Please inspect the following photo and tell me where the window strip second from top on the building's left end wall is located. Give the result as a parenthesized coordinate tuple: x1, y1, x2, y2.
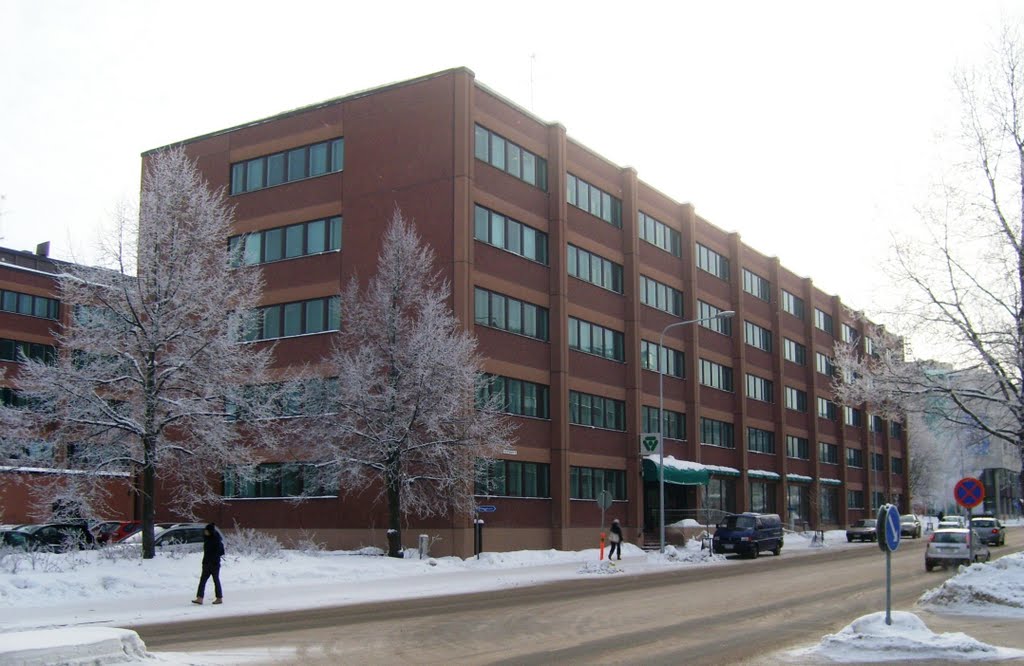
(227, 217, 342, 266)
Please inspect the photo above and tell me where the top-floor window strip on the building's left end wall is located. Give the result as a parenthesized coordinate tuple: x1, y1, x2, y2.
(231, 137, 345, 195)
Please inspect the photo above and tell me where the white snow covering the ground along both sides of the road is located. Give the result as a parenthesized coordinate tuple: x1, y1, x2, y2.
(0, 518, 1024, 664)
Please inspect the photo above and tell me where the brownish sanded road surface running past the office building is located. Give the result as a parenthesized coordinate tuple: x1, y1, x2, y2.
(133, 540, 1024, 664)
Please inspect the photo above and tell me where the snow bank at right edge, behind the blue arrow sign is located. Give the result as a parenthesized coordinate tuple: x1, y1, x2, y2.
(919, 552, 1024, 617)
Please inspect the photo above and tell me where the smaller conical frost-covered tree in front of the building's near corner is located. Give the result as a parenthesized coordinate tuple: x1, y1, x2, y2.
(306, 210, 513, 556)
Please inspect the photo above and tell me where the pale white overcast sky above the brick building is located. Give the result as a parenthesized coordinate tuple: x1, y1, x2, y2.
(0, 0, 1024, 331)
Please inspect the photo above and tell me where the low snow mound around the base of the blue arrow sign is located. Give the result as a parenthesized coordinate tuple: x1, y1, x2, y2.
(786, 611, 1024, 662)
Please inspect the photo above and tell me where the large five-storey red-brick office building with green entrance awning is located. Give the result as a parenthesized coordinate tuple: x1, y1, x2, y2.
(149, 69, 908, 554)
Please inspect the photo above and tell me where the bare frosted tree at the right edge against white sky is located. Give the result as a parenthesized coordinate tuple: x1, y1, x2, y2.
(836, 28, 1024, 491)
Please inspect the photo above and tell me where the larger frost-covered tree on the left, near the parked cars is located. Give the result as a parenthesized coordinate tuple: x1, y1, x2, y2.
(0, 149, 273, 558)
